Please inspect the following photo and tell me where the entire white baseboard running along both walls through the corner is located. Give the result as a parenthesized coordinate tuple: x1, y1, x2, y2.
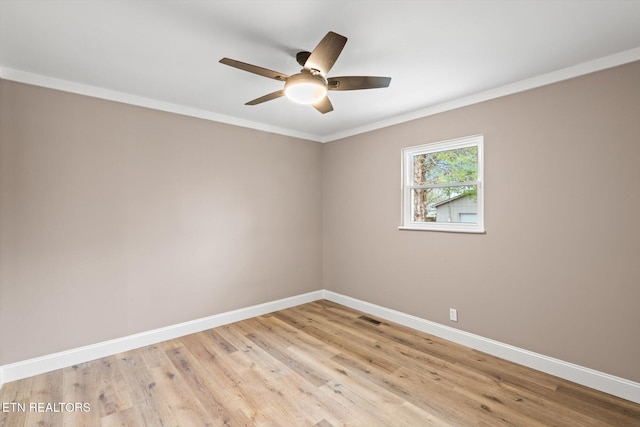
(0, 290, 640, 403)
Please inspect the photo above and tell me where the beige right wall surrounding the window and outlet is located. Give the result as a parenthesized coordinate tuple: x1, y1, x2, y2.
(323, 59, 640, 381)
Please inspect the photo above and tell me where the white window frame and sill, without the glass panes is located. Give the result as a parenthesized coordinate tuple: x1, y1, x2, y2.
(398, 135, 485, 233)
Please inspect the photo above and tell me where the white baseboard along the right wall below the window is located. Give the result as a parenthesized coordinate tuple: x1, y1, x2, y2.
(323, 290, 640, 403)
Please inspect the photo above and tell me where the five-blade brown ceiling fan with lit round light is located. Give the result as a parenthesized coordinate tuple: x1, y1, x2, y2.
(220, 31, 391, 114)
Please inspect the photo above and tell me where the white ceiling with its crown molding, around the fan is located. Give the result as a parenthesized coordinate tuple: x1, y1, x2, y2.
(0, 0, 640, 142)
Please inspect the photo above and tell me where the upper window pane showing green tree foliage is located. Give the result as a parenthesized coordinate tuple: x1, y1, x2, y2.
(413, 147, 478, 185)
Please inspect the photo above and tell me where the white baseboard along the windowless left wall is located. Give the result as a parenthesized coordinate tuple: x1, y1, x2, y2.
(0, 291, 322, 386)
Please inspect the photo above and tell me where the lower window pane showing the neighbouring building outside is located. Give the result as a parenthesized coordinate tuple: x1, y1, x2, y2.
(411, 185, 478, 224)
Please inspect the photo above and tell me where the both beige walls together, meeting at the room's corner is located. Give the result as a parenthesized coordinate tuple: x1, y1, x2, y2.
(0, 63, 640, 381)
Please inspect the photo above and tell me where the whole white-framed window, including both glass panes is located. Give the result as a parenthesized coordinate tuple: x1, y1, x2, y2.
(400, 135, 484, 233)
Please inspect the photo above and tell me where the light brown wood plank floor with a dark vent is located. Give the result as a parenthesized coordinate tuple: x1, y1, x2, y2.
(0, 301, 640, 427)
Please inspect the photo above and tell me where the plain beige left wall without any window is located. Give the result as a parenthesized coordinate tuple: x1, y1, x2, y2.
(0, 81, 322, 365)
